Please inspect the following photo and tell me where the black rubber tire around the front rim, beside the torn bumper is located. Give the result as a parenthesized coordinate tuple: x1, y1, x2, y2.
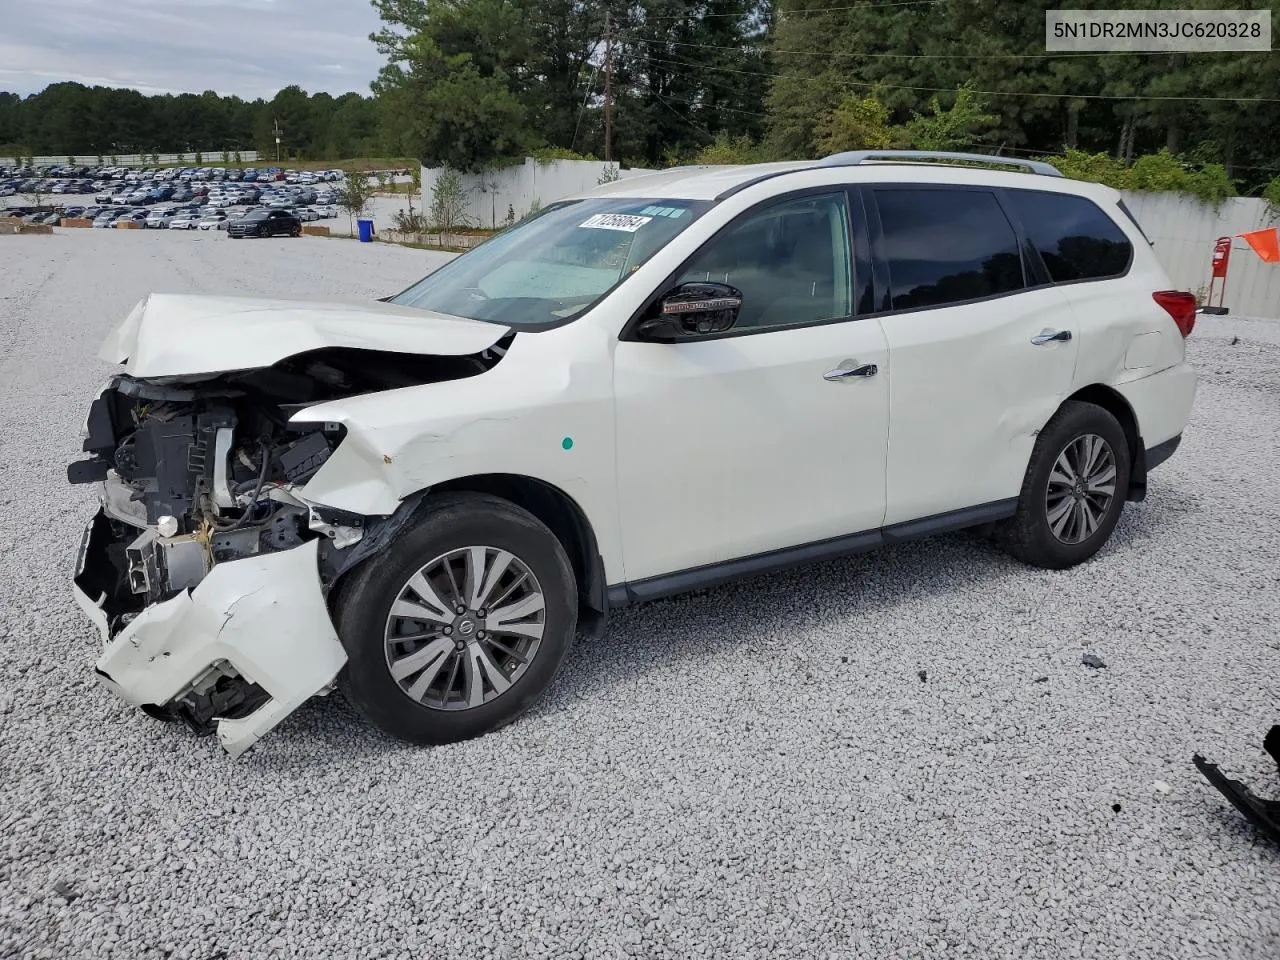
(334, 493, 577, 744)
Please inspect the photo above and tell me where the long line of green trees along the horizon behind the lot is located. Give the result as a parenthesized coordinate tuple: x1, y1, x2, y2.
(0, 0, 1280, 197)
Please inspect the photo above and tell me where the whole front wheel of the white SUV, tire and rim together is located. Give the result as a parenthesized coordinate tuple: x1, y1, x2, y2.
(334, 493, 577, 744)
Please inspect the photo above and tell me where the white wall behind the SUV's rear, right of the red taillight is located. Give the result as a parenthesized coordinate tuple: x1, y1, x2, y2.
(1124, 191, 1280, 319)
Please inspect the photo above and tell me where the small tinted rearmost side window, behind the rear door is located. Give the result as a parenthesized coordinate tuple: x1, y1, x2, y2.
(1006, 189, 1133, 283)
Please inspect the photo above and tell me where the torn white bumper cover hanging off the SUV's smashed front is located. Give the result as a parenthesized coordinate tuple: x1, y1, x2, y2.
(74, 520, 347, 756)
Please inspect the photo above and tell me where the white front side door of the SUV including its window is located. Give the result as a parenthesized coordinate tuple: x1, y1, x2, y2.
(614, 188, 888, 584)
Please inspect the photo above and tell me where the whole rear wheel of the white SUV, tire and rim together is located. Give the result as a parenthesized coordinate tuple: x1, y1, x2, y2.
(997, 401, 1132, 570)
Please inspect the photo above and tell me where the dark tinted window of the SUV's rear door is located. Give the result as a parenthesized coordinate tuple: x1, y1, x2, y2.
(876, 188, 1027, 310)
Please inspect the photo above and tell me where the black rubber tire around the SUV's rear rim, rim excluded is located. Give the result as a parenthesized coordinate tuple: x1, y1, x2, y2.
(997, 401, 1132, 570)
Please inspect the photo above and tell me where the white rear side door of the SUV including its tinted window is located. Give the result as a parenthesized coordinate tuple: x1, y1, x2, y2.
(864, 184, 1079, 525)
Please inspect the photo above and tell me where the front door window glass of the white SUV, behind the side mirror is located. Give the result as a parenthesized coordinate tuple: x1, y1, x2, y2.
(678, 192, 852, 330)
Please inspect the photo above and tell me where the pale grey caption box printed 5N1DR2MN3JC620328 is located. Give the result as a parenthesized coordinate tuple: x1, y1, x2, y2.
(1044, 10, 1271, 54)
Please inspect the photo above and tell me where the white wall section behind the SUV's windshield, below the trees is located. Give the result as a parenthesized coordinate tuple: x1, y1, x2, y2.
(422, 157, 653, 227)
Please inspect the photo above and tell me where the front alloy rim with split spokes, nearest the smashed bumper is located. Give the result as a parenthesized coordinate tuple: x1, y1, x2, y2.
(385, 547, 547, 710)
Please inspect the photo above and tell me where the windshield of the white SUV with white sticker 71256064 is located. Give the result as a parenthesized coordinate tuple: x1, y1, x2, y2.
(390, 197, 710, 326)
